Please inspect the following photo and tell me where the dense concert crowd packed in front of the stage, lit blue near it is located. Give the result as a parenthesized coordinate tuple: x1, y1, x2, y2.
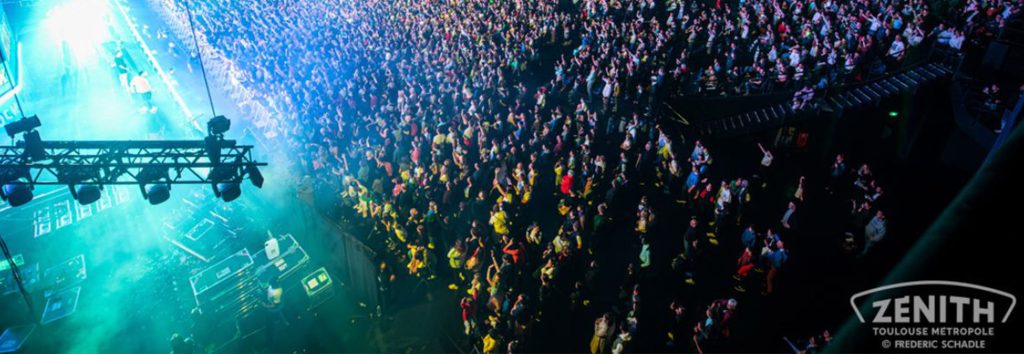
(146, 0, 1019, 353)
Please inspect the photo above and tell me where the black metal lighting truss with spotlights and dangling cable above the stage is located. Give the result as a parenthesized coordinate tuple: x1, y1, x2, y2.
(0, 133, 267, 321)
